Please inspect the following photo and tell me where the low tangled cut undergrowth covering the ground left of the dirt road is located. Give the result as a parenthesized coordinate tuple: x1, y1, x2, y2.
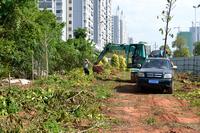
(0, 69, 112, 132)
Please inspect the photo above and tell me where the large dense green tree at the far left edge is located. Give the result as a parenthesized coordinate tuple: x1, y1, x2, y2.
(0, 0, 39, 76)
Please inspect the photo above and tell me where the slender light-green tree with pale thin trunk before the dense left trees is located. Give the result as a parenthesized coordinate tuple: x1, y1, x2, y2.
(36, 10, 64, 76)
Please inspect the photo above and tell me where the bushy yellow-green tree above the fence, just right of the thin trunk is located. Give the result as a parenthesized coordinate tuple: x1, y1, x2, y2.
(172, 36, 190, 57)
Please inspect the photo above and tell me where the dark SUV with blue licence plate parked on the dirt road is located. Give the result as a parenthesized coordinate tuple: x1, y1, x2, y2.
(137, 58, 177, 94)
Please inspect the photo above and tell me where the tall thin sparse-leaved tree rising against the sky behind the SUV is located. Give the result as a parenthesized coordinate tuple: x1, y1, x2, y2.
(157, 0, 176, 56)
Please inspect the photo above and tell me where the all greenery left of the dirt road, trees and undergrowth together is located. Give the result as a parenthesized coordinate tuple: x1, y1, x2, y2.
(0, 0, 125, 133)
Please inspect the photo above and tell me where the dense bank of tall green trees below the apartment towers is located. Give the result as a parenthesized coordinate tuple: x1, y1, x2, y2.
(0, 0, 94, 78)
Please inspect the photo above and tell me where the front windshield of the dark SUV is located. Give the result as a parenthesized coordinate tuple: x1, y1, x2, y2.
(142, 59, 171, 69)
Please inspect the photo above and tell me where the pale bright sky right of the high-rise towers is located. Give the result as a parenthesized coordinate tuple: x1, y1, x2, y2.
(112, 0, 200, 48)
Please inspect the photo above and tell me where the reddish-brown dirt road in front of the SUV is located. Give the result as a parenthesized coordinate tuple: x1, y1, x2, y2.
(105, 83, 200, 133)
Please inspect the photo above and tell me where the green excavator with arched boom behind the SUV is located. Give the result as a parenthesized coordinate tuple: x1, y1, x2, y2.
(93, 43, 147, 82)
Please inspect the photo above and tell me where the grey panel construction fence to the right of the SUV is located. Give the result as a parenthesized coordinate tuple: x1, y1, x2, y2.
(171, 56, 200, 75)
